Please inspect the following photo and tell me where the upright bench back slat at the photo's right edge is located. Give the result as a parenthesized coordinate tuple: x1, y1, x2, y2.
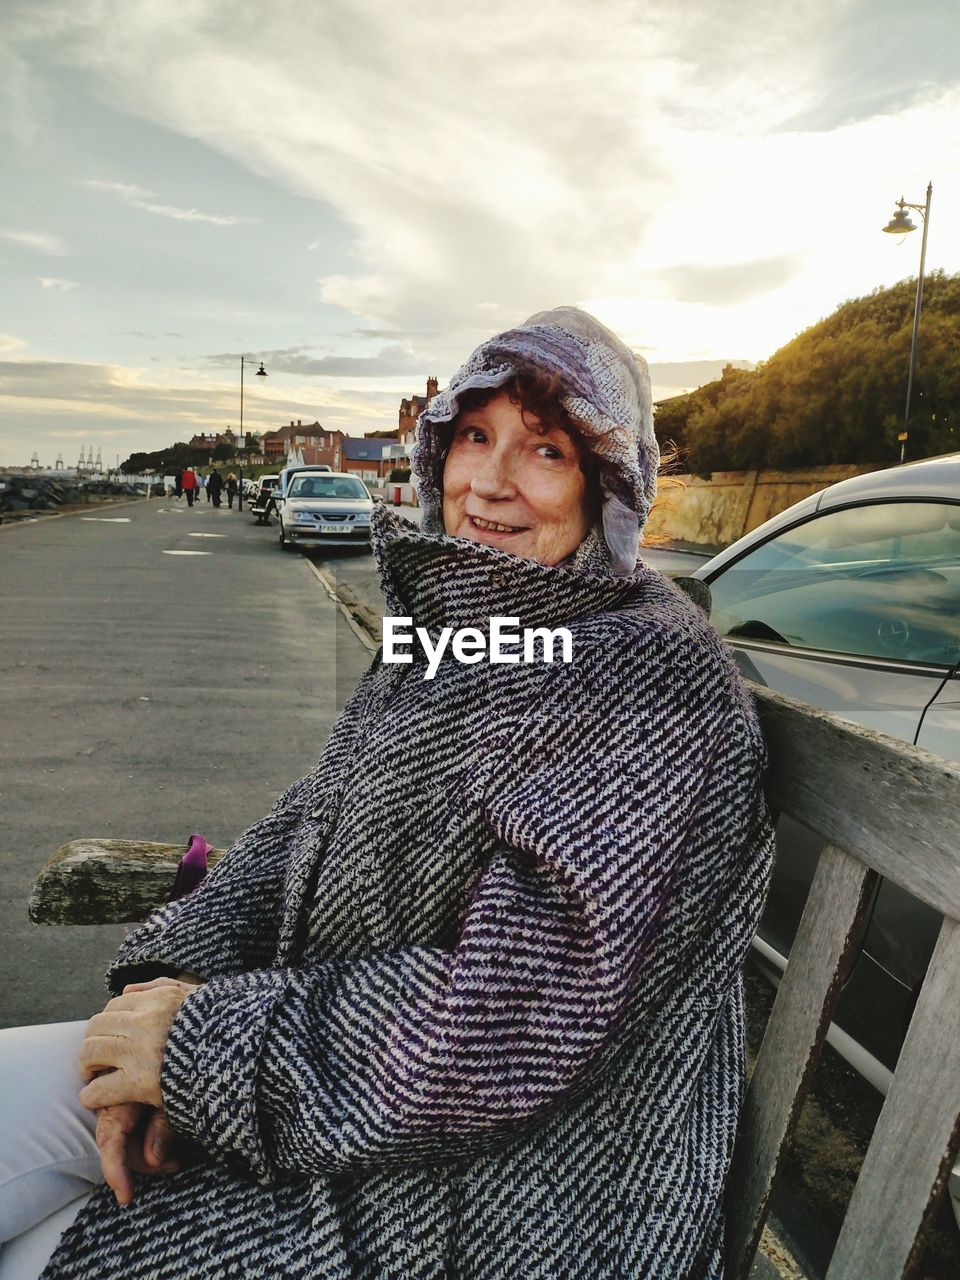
(827, 920, 960, 1280)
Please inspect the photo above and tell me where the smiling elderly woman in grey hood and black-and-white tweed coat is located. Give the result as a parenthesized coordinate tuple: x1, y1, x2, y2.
(0, 307, 772, 1280)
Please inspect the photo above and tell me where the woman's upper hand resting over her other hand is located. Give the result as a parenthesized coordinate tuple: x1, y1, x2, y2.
(79, 978, 196, 1124)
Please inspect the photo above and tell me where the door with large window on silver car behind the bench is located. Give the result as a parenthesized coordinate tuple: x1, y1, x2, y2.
(704, 500, 960, 1066)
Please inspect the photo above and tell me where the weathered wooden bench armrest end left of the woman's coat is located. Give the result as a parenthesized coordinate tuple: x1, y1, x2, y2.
(29, 840, 223, 924)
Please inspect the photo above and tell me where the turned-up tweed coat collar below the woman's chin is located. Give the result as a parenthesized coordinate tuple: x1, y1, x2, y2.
(371, 504, 659, 630)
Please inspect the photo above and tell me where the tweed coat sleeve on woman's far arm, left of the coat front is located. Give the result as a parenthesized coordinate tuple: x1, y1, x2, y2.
(106, 668, 381, 995)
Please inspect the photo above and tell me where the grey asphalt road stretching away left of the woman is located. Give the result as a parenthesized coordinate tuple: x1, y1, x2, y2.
(0, 499, 370, 1027)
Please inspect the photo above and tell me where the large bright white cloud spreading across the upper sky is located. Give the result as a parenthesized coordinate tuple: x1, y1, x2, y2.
(17, 0, 960, 367)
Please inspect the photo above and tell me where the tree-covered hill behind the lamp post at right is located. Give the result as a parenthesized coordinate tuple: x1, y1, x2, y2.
(655, 271, 960, 476)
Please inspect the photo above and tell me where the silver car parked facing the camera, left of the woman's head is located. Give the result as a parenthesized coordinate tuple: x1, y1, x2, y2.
(279, 471, 374, 550)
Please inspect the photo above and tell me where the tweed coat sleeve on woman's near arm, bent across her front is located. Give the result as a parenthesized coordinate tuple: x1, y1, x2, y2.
(161, 634, 759, 1183)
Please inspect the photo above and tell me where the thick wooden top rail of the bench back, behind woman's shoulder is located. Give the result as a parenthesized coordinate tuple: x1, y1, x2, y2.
(750, 682, 960, 919)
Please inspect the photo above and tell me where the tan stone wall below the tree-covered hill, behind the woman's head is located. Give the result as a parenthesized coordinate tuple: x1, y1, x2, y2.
(646, 462, 886, 549)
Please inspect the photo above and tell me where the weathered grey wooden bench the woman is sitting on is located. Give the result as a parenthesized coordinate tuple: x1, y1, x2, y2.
(29, 686, 960, 1280)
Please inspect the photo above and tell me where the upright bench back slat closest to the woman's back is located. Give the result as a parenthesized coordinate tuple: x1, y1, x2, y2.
(727, 845, 877, 1280)
